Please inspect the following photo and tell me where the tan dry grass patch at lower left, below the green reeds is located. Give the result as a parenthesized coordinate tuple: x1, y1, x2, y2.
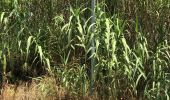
(0, 77, 73, 100)
